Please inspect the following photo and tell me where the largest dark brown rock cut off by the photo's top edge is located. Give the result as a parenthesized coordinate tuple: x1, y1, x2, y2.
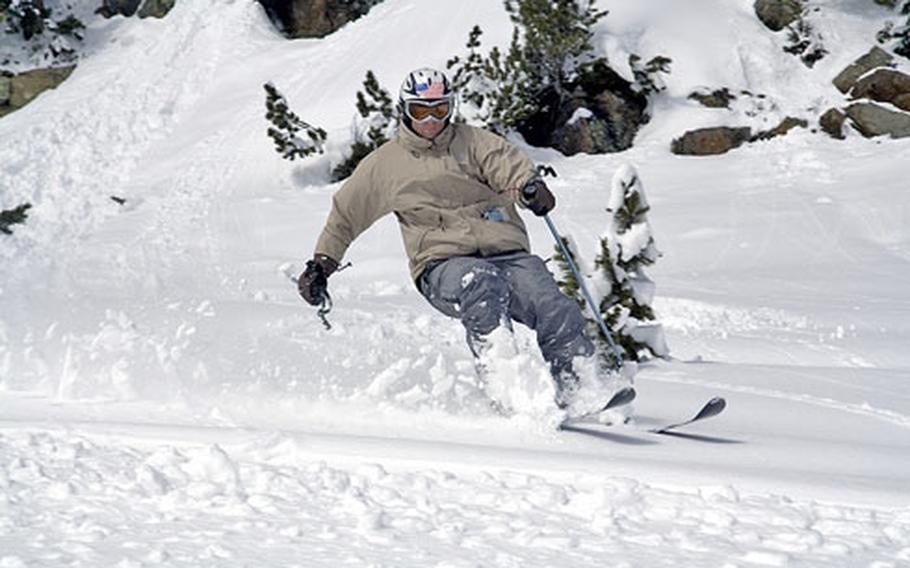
(259, 0, 382, 38)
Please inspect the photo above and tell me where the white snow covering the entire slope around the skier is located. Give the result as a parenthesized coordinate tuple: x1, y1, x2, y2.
(0, 0, 910, 568)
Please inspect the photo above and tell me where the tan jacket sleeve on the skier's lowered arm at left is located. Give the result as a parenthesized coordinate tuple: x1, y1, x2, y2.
(314, 152, 391, 262)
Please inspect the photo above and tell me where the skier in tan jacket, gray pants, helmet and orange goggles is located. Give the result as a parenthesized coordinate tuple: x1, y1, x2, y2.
(298, 68, 602, 416)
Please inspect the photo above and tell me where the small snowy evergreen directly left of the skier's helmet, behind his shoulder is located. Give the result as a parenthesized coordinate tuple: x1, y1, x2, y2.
(332, 71, 398, 181)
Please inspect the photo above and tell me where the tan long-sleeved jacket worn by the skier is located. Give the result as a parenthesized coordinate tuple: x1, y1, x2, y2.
(315, 124, 535, 281)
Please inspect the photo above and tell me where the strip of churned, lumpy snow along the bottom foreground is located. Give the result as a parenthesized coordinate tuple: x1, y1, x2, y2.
(0, 429, 910, 567)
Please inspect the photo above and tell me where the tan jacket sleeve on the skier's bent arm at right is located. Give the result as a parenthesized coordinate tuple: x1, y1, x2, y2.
(472, 128, 537, 201)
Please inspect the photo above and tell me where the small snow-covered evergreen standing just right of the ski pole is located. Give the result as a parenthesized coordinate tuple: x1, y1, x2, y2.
(594, 165, 669, 361)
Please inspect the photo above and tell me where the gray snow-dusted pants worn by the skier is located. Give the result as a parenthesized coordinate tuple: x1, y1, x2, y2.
(419, 252, 594, 382)
